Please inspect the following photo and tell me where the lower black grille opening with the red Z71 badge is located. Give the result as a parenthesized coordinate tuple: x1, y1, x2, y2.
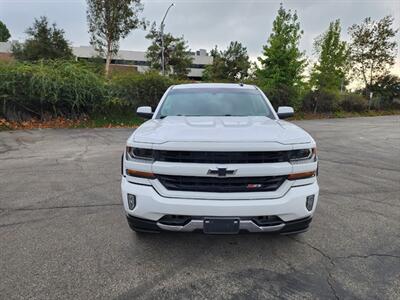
(157, 175, 287, 193)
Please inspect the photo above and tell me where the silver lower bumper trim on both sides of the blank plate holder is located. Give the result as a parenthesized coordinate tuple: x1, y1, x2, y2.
(157, 220, 285, 232)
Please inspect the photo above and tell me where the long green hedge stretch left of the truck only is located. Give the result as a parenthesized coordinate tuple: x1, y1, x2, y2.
(0, 61, 177, 120)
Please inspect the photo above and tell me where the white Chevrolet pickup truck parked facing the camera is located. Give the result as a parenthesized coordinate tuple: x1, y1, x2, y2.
(121, 84, 319, 234)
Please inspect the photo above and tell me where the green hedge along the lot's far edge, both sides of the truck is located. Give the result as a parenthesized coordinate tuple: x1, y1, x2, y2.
(0, 61, 394, 121)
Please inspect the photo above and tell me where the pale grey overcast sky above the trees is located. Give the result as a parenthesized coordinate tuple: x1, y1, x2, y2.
(0, 0, 400, 73)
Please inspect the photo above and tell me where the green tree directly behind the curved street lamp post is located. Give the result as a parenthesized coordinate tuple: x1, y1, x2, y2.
(146, 22, 193, 78)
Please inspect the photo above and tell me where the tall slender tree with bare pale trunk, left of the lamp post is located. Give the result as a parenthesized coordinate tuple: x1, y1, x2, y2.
(87, 0, 146, 75)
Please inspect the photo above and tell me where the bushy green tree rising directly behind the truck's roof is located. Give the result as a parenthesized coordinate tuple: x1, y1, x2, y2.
(203, 41, 251, 81)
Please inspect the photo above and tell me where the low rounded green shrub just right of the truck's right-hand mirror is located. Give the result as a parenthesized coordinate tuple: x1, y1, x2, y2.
(302, 90, 339, 113)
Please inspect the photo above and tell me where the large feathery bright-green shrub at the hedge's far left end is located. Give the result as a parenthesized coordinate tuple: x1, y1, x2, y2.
(0, 61, 106, 119)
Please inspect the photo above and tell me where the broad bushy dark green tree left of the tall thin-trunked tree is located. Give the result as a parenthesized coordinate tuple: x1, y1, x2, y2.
(12, 16, 73, 61)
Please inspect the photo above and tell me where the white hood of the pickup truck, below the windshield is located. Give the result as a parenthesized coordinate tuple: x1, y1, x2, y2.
(129, 116, 313, 144)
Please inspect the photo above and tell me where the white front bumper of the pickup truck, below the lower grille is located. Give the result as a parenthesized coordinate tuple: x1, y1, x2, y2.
(121, 177, 319, 232)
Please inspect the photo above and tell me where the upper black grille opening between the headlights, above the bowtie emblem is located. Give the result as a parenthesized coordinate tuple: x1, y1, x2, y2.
(154, 150, 290, 164)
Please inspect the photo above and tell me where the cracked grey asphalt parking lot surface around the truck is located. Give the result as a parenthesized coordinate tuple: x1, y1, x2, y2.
(0, 116, 400, 299)
